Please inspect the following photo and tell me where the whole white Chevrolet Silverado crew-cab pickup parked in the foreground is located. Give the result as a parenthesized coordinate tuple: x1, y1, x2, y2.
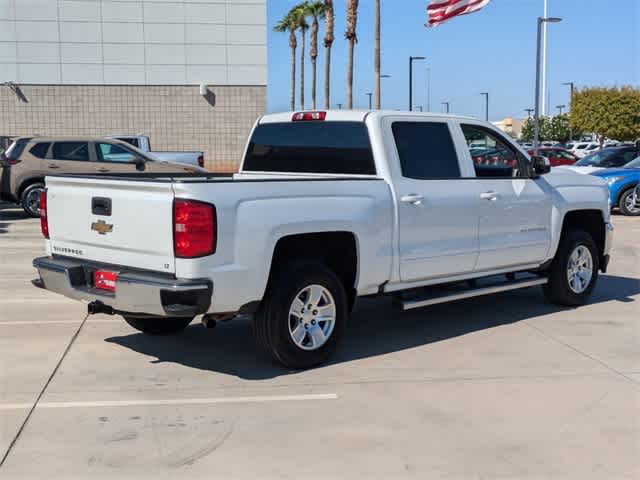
(34, 111, 613, 368)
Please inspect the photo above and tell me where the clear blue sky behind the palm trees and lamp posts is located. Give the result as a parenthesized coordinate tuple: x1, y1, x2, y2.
(267, 0, 640, 120)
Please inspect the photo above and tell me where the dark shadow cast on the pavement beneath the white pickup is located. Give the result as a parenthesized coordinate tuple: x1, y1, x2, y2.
(105, 275, 640, 380)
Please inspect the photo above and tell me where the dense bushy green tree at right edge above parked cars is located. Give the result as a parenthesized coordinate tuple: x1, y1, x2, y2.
(570, 86, 640, 142)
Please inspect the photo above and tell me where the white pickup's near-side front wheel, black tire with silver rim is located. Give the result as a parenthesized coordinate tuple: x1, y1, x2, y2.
(542, 230, 600, 307)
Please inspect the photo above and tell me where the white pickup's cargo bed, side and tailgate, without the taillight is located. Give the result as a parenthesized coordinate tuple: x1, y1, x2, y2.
(46, 173, 393, 311)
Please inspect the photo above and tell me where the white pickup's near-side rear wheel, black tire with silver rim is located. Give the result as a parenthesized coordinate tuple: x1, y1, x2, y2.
(253, 260, 349, 369)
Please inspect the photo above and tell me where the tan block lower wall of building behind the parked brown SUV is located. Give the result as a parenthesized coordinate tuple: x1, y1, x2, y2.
(0, 85, 266, 171)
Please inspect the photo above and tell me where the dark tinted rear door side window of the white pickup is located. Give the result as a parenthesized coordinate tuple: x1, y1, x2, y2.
(391, 122, 460, 180)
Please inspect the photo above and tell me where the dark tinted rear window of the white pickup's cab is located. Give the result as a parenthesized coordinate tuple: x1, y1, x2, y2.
(243, 121, 376, 175)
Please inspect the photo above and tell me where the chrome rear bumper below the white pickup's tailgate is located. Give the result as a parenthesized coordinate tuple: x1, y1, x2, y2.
(33, 257, 213, 317)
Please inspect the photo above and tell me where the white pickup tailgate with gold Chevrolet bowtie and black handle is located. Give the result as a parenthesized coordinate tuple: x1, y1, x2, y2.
(46, 177, 175, 273)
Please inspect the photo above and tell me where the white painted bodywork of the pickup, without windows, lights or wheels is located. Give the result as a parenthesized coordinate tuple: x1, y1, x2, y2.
(38, 111, 610, 313)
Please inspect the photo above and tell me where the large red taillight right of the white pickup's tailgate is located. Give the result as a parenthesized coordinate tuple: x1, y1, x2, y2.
(173, 199, 217, 258)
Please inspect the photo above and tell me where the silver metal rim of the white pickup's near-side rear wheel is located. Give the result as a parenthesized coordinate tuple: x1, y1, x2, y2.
(289, 285, 336, 350)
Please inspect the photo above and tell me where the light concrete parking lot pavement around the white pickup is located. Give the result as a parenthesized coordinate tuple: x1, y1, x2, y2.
(0, 204, 640, 480)
